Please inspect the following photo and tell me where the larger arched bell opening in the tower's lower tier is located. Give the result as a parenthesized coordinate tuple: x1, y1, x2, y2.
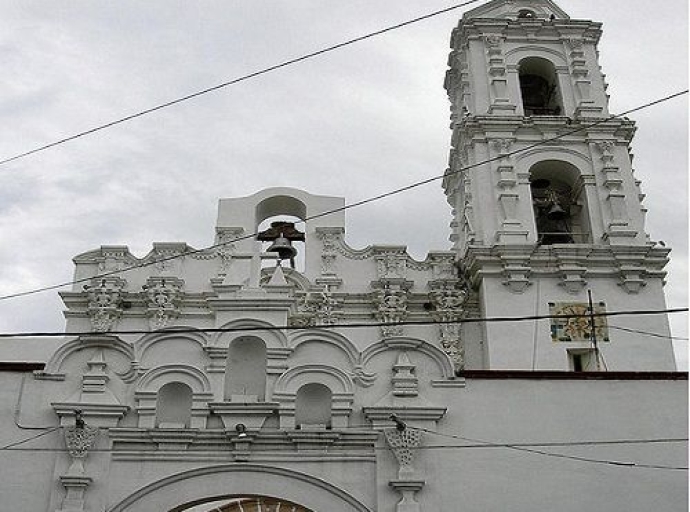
(529, 160, 591, 245)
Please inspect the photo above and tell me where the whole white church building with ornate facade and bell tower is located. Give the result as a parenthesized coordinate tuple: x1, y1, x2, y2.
(0, 0, 688, 512)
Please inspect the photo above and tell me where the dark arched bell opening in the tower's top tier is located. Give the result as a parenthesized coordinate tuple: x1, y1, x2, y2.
(518, 57, 563, 117)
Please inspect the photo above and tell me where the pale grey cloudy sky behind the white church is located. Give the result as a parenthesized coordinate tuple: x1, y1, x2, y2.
(0, 0, 688, 369)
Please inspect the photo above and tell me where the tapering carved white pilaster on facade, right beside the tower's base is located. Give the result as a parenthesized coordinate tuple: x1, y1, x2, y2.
(429, 282, 467, 371)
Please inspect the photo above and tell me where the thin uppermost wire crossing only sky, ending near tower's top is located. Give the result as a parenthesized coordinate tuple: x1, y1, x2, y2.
(0, 0, 479, 165)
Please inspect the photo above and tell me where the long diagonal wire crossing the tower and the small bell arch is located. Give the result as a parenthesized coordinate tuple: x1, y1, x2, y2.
(0, 89, 688, 301)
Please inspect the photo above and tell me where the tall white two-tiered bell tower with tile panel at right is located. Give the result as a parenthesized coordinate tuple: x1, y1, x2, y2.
(444, 0, 675, 371)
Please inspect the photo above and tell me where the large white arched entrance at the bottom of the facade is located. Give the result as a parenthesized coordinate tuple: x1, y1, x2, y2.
(107, 463, 373, 512)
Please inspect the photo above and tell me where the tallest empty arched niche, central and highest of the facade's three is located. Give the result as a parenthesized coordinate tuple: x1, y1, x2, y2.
(224, 336, 266, 402)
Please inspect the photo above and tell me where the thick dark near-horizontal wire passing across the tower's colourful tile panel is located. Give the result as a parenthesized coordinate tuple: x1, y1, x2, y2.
(0, 308, 688, 339)
